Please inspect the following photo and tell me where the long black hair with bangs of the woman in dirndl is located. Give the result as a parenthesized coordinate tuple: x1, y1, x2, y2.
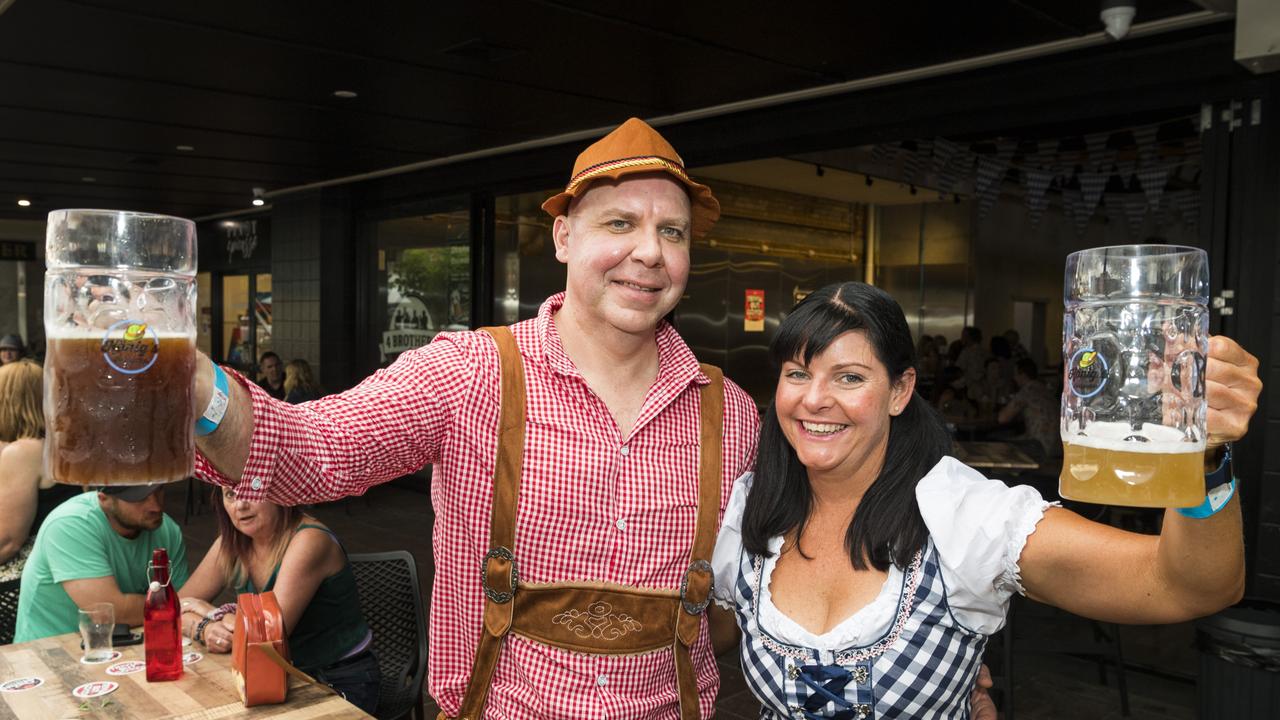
(742, 282, 951, 571)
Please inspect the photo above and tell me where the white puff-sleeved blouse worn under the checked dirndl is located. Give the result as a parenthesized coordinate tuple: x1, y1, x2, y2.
(712, 457, 1053, 651)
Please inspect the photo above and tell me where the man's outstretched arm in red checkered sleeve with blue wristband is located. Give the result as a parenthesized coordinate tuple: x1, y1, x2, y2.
(184, 333, 476, 505)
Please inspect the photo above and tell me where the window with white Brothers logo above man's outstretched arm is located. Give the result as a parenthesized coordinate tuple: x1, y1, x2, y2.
(374, 205, 471, 366)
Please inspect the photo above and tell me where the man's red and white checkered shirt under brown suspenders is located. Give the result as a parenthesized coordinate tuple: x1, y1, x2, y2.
(197, 295, 759, 719)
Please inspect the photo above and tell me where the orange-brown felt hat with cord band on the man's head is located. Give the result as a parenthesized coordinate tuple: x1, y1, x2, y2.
(543, 118, 719, 237)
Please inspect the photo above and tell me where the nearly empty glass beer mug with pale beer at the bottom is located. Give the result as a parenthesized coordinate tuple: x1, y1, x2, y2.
(1059, 245, 1208, 507)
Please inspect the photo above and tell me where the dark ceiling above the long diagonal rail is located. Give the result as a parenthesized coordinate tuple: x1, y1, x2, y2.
(0, 0, 1199, 218)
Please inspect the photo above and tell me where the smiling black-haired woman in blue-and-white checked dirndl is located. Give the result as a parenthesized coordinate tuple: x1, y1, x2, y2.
(713, 282, 1262, 720)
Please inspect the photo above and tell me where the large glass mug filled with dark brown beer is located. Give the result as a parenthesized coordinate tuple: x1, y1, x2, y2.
(45, 210, 196, 486)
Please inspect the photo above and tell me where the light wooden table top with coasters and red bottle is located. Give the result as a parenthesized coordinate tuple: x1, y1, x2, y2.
(0, 633, 369, 720)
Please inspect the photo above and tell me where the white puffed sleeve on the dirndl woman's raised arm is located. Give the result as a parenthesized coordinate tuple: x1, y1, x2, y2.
(915, 457, 1053, 634)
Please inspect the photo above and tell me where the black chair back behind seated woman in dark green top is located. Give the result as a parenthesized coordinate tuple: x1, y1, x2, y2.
(349, 550, 426, 720)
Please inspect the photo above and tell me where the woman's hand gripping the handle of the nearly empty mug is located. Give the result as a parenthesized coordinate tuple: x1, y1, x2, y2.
(1204, 336, 1262, 447)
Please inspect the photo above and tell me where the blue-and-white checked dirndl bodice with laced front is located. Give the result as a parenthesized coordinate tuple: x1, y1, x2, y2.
(735, 541, 986, 720)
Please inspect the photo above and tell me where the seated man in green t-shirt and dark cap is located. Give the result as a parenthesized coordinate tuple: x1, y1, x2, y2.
(14, 484, 187, 642)
